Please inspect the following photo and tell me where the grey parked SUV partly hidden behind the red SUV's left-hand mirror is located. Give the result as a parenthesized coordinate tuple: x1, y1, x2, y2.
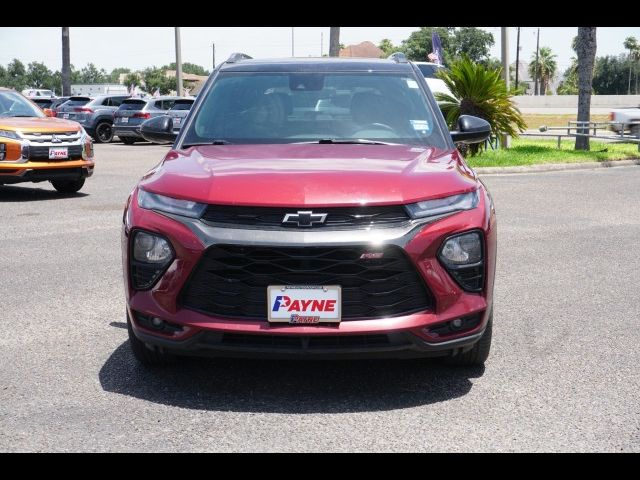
(114, 96, 180, 145)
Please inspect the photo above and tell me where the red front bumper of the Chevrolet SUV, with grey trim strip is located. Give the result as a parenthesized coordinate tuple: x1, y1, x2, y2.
(122, 188, 496, 358)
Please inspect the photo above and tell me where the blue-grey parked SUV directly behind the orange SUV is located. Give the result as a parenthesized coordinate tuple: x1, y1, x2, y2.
(56, 95, 129, 143)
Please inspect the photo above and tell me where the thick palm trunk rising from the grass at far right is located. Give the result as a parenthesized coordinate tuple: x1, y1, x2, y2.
(575, 27, 597, 150)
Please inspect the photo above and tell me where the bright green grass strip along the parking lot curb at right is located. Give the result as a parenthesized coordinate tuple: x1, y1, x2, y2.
(466, 138, 640, 168)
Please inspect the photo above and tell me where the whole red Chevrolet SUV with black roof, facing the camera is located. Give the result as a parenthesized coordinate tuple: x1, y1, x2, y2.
(122, 54, 496, 365)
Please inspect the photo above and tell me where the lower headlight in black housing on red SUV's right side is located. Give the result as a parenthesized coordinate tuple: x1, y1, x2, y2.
(438, 231, 484, 292)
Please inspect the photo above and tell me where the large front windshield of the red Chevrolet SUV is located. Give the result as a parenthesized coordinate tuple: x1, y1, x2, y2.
(182, 71, 446, 148)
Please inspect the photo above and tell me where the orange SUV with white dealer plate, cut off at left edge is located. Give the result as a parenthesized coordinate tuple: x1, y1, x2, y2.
(0, 88, 94, 193)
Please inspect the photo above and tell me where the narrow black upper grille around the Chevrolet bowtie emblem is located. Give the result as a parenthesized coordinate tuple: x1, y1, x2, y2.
(202, 205, 410, 229)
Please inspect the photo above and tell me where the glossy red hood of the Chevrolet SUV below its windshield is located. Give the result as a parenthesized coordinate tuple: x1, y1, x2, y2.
(140, 144, 478, 207)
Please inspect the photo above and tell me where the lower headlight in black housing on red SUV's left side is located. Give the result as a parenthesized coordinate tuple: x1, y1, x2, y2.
(130, 230, 174, 290)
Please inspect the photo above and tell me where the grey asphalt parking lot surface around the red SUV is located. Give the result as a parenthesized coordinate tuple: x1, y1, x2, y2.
(0, 143, 640, 452)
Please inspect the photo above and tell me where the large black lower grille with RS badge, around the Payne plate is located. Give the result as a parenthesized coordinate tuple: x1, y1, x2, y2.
(180, 245, 433, 320)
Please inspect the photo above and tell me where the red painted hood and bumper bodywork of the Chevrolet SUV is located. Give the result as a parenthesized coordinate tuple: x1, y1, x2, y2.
(122, 145, 496, 343)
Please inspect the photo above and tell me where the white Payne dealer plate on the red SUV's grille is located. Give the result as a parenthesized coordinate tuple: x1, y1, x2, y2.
(267, 285, 342, 324)
